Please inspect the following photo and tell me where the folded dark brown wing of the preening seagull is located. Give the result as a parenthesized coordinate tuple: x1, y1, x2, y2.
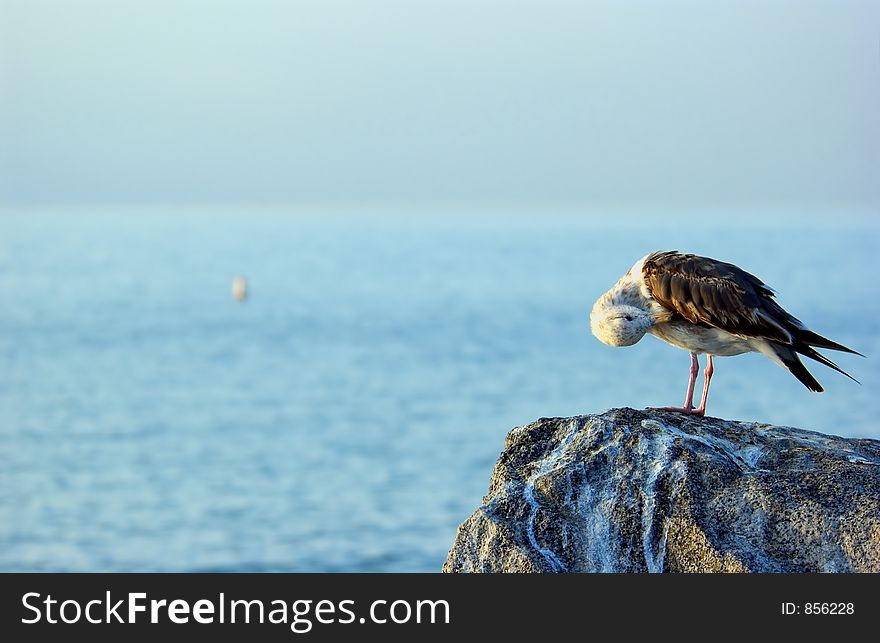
(642, 251, 794, 345)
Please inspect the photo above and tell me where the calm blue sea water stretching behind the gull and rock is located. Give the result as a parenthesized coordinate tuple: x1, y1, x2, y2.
(0, 208, 880, 571)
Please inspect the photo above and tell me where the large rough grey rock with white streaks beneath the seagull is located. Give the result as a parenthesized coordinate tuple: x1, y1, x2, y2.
(443, 409, 880, 572)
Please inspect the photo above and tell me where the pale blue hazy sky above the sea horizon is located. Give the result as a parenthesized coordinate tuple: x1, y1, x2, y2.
(0, 0, 880, 207)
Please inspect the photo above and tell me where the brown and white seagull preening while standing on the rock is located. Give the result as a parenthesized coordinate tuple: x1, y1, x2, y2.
(590, 250, 864, 416)
